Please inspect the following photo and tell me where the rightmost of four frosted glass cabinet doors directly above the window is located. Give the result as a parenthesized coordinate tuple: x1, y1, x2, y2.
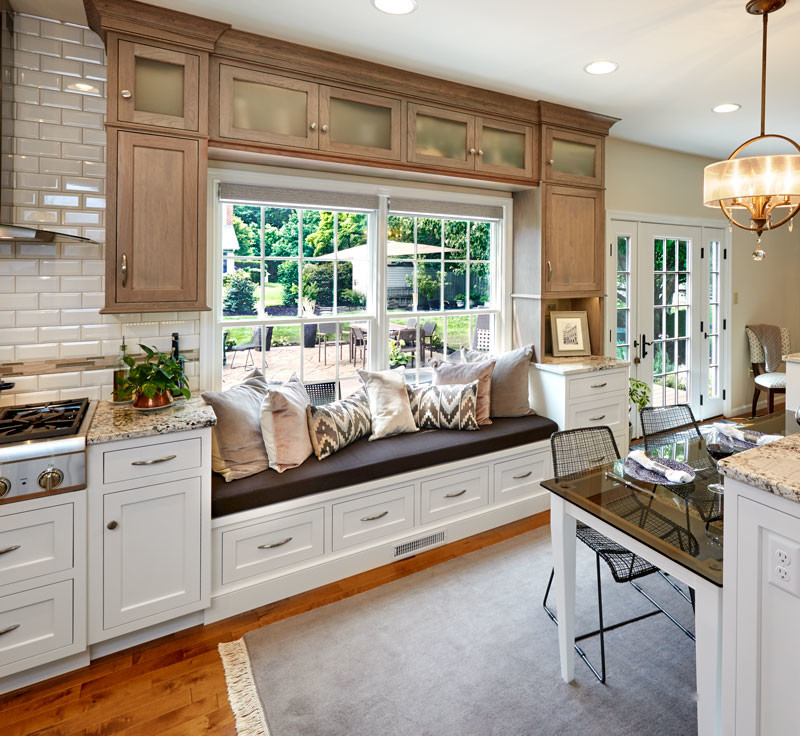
(475, 117, 534, 177)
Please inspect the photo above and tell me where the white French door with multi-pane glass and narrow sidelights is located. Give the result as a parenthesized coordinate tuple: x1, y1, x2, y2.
(609, 220, 727, 419)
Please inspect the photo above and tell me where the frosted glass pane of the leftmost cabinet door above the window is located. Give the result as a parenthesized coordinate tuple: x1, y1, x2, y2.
(233, 79, 308, 138)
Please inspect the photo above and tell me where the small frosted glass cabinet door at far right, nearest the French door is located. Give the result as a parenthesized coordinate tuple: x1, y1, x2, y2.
(542, 126, 604, 187)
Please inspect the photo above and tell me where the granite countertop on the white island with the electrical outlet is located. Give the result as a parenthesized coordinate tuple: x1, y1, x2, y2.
(717, 434, 800, 503)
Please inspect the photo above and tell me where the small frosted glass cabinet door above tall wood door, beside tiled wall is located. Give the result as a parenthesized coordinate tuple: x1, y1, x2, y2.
(117, 41, 205, 131)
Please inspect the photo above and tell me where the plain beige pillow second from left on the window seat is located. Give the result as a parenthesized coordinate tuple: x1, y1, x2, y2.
(261, 374, 313, 473)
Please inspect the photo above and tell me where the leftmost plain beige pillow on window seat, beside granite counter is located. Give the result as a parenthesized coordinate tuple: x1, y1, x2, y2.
(202, 370, 269, 482)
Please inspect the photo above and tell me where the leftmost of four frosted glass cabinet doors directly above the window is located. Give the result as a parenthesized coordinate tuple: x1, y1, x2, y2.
(219, 64, 319, 148)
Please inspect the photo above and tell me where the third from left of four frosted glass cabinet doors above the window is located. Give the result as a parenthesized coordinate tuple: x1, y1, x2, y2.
(408, 103, 476, 170)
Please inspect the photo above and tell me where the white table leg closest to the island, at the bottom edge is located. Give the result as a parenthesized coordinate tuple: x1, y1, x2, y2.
(695, 583, 722, 736)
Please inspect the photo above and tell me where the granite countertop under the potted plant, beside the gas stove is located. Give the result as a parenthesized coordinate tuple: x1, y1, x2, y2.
(86, 396, 217, 445)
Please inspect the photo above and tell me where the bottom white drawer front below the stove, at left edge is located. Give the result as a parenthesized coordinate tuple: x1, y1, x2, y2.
(0, 580, 72, 667)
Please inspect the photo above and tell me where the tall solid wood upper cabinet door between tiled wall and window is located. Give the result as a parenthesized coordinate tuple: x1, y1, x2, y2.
(105, 131, 206, 312)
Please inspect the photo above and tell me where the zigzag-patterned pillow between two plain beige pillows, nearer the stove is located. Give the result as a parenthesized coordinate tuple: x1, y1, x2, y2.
(306, 391, 372, 460)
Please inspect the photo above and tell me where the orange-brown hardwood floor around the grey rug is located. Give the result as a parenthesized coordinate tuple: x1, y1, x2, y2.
(0, 511, 550, 736)
